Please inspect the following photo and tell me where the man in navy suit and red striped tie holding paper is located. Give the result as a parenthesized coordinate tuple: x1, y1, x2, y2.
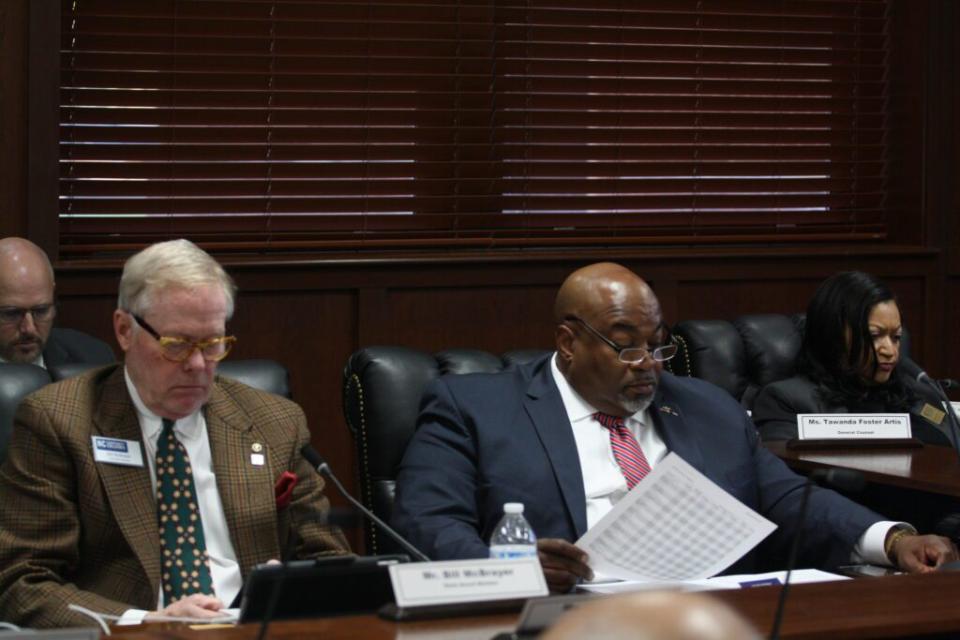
(393, 263, 957, 591)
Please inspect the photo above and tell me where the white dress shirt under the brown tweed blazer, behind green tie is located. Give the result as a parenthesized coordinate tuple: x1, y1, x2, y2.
(122, 368, 243, 624)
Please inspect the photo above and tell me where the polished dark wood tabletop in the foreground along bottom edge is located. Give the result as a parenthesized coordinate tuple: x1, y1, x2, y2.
(113, 573, 960, 640)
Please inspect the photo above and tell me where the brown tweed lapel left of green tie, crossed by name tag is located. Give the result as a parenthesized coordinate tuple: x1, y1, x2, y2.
(93, 366, 160, 593)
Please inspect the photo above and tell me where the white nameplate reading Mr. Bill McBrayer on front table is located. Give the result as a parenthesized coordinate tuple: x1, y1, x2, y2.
(388, 557, 547, 607)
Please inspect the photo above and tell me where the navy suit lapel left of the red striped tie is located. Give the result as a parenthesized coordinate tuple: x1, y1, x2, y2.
(523, 360, 587, 538)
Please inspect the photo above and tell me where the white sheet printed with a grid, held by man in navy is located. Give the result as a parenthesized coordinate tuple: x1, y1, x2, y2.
(576, 453, 777, 582)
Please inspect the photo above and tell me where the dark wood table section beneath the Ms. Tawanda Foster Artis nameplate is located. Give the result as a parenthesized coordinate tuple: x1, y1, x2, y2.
(764, 442, 960, 498)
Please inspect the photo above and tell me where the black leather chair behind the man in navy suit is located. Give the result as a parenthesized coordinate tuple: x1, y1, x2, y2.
(343, 346, 548, 554)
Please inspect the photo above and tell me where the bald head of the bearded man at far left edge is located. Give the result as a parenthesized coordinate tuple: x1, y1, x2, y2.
(0, 237, 54, 363)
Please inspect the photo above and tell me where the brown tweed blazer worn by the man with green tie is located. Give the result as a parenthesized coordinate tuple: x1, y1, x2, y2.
(0, 365, 348, 627)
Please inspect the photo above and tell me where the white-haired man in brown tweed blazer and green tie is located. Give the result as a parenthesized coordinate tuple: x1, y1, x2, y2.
(0, 240, 347, 626)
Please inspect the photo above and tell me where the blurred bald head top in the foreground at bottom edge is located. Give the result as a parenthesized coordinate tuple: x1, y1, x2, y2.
(541, 591, 760, 640)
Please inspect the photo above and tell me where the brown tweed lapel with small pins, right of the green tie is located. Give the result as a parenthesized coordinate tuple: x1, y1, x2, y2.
(204, 384, 281, 575)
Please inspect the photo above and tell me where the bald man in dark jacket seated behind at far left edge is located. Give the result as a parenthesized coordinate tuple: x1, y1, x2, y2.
(0, 237, 115, 368)
